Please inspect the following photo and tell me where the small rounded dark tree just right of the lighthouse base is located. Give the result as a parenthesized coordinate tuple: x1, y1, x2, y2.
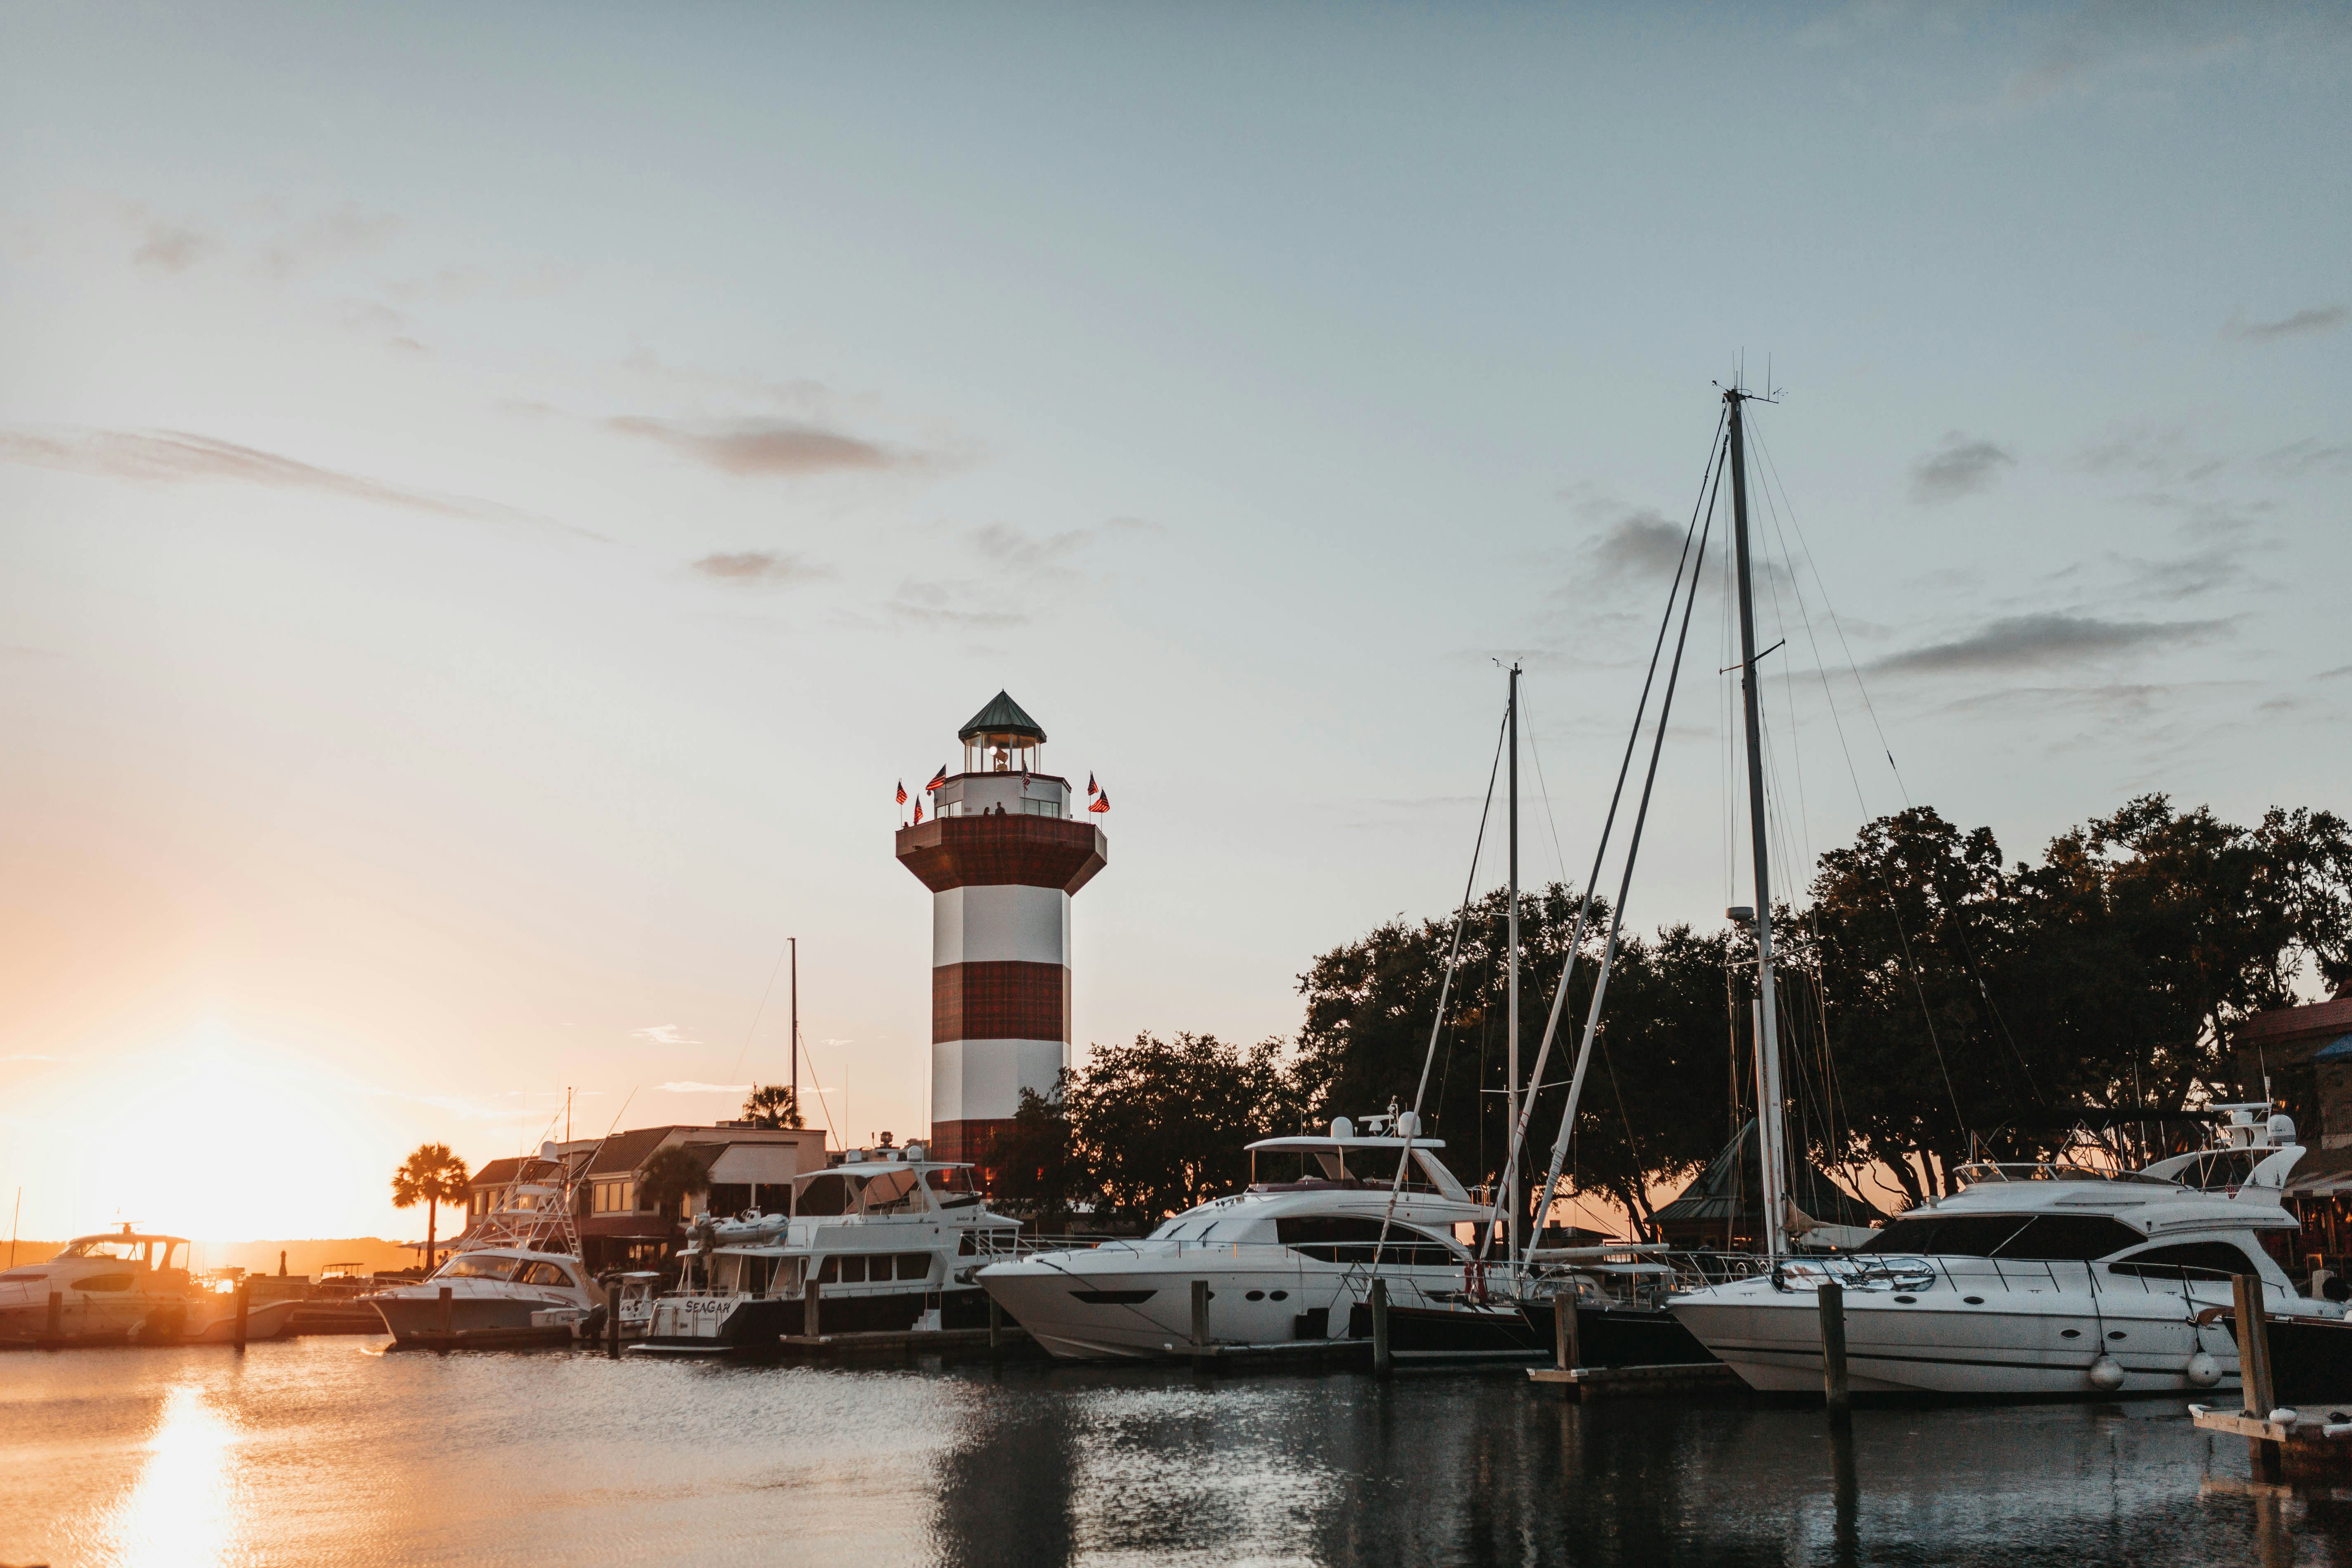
(1061, 1034, 1303, 1223)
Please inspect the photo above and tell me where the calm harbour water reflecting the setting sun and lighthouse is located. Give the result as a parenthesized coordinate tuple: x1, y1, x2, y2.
(0, 1338, 2352, 1568)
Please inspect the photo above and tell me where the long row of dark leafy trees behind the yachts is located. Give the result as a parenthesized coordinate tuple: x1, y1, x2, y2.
(995, 795, 2352, 1225)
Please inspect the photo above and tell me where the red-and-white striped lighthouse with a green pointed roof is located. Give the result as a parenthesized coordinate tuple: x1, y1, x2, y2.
(898, 691, 1108, 1168)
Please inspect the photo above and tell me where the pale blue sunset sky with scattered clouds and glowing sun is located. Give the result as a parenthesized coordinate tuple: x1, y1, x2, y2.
(0, 2, 2352, 1239)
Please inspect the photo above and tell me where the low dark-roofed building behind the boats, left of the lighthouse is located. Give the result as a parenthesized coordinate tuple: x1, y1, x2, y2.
(466, 1122, 826, 1274)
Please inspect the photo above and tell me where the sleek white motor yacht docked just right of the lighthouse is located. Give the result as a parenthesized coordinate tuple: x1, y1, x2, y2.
(978, 1112, 1526, 1361)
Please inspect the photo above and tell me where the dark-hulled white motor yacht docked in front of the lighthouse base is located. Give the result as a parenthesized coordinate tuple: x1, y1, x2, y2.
(638, 1143, 1021, 1352)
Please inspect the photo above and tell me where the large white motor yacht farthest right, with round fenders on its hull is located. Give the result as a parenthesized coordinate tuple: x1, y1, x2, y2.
(1667, 1103, 2343, 1399)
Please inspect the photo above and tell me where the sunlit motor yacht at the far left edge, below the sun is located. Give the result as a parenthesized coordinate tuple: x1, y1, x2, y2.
(0, 1225, 299, 1345)
